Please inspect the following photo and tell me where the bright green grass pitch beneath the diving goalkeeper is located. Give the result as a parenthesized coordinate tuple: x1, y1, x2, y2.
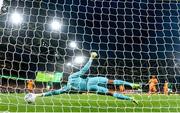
(0, 93, 180, 112)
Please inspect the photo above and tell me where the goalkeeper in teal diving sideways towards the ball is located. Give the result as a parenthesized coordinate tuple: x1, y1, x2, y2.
(35, 52, 140, 104)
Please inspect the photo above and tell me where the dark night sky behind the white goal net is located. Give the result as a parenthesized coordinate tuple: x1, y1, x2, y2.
(0, 0, 180, 82)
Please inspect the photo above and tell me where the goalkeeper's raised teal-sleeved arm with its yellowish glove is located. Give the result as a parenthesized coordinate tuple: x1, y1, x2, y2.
(69, 52, 97, 78)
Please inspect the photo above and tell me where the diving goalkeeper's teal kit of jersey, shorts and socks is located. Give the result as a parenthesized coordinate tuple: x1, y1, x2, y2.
(44, 59, 133, 96)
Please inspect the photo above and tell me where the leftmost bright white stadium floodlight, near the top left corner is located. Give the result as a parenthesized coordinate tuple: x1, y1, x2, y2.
(10, 12, 23, 24)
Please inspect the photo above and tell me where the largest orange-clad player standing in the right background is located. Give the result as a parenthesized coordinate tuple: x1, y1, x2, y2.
(148, 75, 158, 94)
